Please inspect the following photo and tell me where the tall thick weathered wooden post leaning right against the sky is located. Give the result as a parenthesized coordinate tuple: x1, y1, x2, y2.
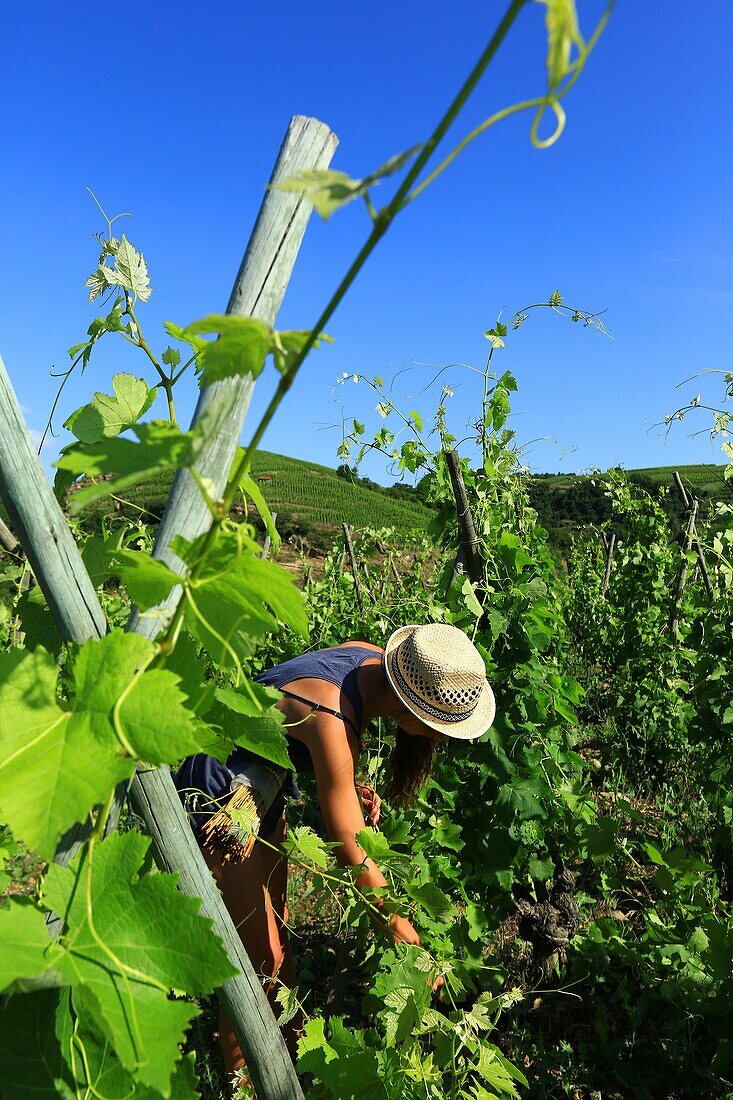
(129, 114, 338, 638)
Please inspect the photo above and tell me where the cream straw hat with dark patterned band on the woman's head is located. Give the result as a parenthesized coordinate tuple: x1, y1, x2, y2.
(384, 623, 496, 739)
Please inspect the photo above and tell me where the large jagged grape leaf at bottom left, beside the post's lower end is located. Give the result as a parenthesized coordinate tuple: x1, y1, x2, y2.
(43, 833, 236, 1095)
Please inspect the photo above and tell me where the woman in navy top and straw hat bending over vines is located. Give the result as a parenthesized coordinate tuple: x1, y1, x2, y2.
(175, 624, 494, 1073)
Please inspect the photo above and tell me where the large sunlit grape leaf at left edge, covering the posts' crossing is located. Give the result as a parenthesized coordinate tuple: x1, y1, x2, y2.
(0, 630, 200, 859)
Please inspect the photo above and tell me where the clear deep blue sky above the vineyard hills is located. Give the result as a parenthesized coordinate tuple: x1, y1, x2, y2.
(0, 0, 733, 480)
